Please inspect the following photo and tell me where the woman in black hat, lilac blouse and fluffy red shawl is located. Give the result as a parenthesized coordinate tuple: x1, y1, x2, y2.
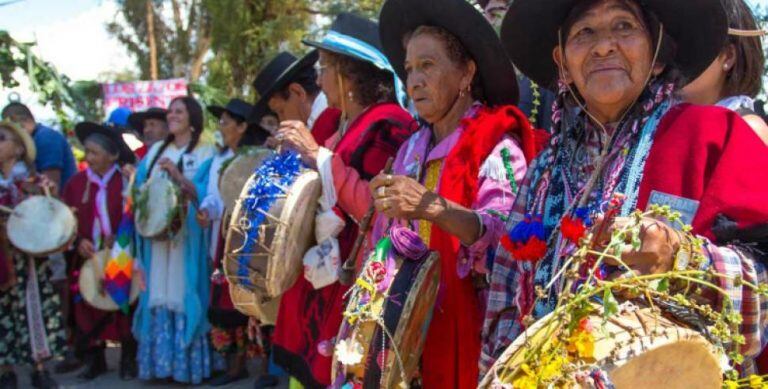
(352, 0, 537, 388)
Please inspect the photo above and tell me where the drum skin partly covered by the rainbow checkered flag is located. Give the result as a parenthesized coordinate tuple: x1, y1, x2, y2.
(77, 250, 141, 311)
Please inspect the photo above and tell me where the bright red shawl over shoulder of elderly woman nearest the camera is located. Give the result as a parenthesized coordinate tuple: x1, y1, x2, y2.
(637, 104, 768, 240)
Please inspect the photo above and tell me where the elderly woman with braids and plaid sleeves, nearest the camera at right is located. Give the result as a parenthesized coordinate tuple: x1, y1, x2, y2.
(481, 0, 768, 376)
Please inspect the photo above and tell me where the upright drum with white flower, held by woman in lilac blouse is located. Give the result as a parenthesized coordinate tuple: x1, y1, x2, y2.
(331, 249, 441, 388)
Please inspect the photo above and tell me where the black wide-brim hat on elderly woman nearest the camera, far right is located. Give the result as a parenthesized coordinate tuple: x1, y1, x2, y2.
(501, 0, 728, 87)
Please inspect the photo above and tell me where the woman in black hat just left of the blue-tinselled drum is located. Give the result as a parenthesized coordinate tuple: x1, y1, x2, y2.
(197, 99, 269, 386)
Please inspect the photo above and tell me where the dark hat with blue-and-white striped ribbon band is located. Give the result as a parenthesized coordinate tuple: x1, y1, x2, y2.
(301, 12, 381, 61)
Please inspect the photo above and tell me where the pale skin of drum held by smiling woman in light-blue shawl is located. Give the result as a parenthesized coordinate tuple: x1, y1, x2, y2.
(136, 175, 184, 240)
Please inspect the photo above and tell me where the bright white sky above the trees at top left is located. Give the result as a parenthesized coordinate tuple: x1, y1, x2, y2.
(0, 0, 768, 123)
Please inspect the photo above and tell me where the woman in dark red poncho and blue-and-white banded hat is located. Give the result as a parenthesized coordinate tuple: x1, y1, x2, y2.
(273, 14, 413, 387)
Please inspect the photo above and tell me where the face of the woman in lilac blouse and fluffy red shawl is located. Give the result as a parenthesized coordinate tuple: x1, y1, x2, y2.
(405, 34, 473, 123)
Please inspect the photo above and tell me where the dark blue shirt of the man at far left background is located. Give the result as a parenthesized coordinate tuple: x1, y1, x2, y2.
(32, 124, 77, 188)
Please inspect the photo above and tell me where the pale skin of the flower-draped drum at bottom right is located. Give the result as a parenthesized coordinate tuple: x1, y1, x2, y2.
(479, 308, 723, 389)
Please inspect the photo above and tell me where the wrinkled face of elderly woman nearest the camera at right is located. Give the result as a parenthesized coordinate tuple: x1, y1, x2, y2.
(553, 0, 663, 118)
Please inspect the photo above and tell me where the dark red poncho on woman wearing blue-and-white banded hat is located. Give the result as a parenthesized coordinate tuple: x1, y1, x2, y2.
(273, 103, 413, 388)
